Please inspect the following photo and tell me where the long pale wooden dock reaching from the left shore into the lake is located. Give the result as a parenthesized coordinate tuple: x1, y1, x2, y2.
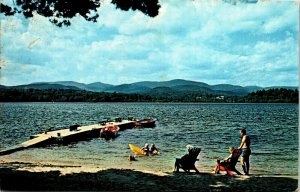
(0, 119, 135, 155)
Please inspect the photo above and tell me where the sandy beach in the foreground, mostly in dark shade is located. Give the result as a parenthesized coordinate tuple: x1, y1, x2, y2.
(0, 160, 298, 192)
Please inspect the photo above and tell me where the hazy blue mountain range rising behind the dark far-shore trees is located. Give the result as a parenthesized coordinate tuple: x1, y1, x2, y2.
(0, 79, 298, 96)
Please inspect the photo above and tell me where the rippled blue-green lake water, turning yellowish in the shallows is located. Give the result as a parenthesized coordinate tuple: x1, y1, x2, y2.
(0, 103, 298, 175)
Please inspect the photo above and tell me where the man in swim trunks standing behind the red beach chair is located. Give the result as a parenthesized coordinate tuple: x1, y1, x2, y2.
(239, 129, 251, 175)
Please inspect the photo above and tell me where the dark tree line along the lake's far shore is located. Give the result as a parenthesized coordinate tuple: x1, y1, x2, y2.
(0, 88, 299, 103)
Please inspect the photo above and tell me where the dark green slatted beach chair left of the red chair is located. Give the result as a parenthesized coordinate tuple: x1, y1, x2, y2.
(174, 148, 201, 173)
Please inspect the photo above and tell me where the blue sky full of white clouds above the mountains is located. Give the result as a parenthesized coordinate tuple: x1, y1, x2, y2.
(0, 0, 299, 87)
